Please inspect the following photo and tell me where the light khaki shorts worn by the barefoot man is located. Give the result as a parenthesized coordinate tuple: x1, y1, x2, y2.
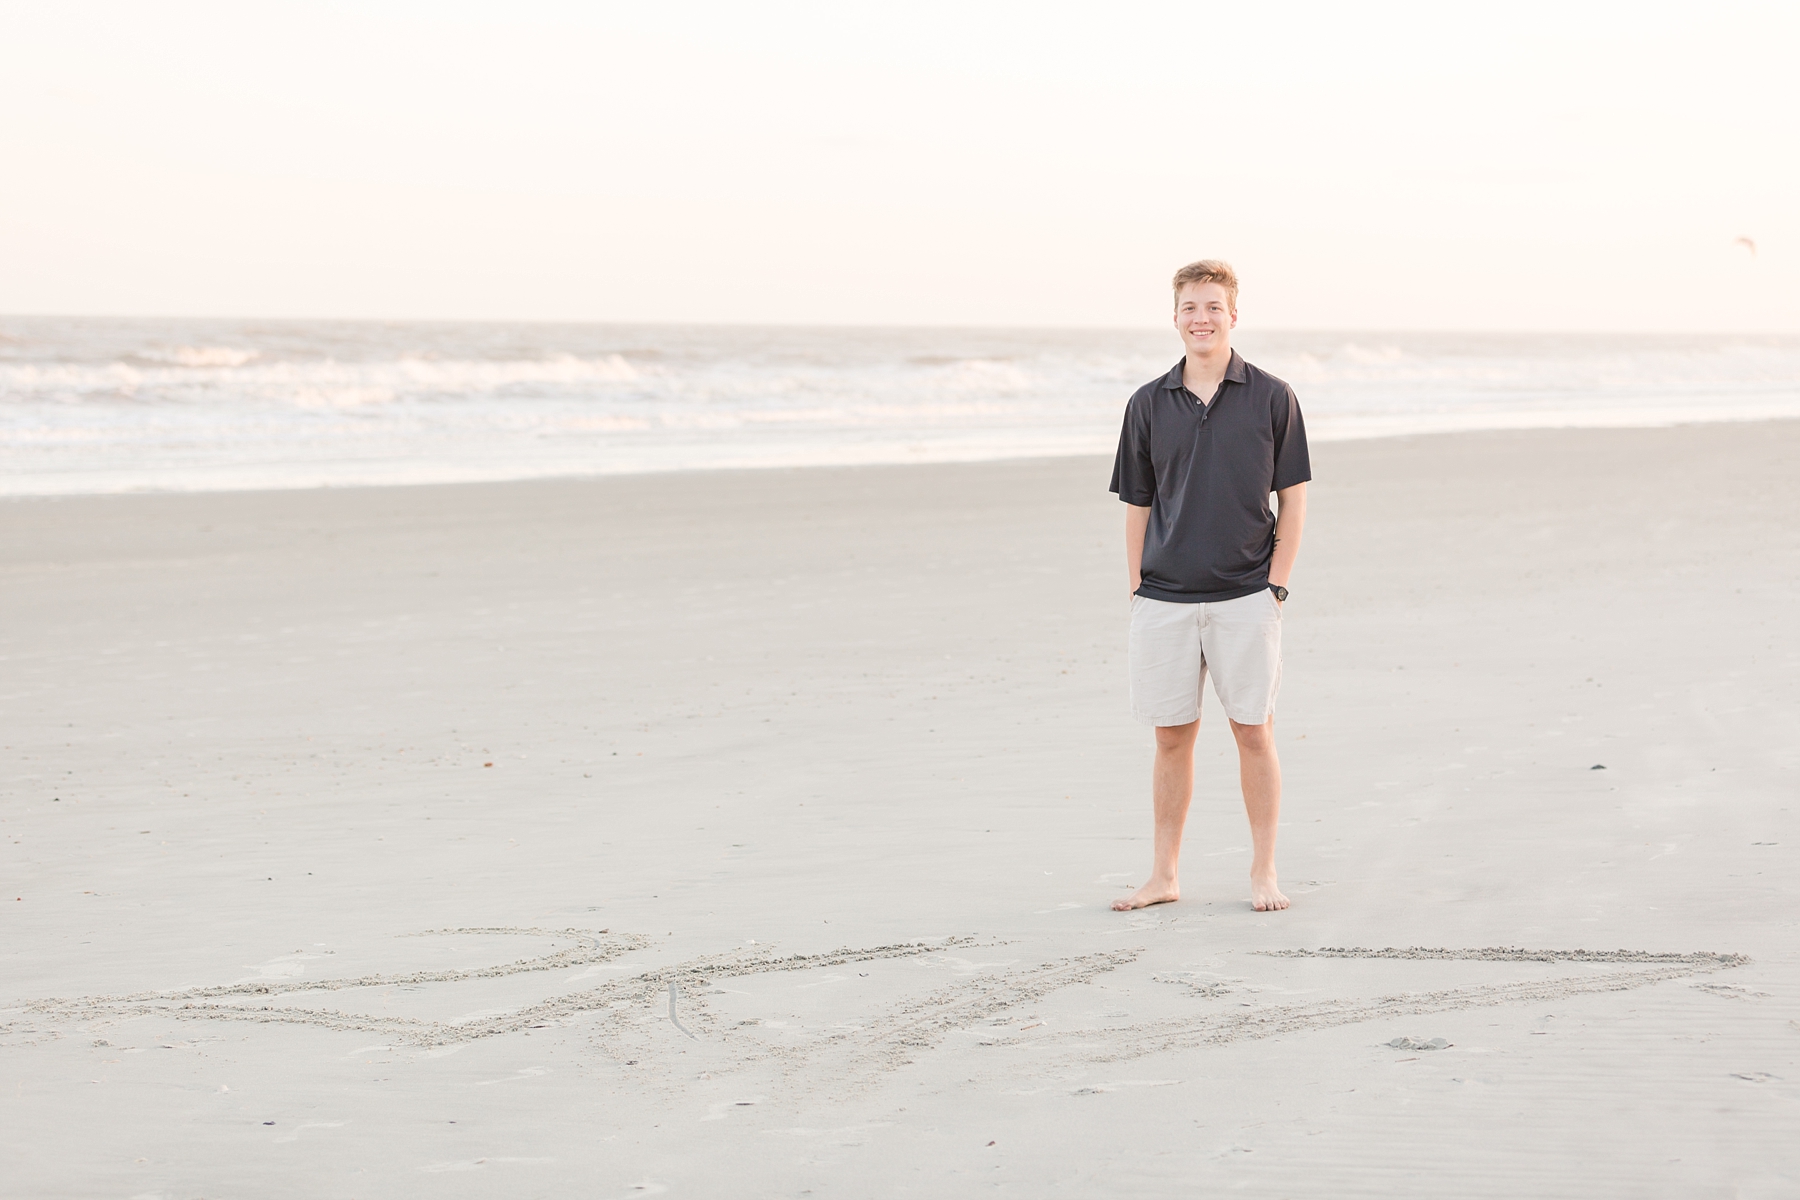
(1130, 588, 1282, 725)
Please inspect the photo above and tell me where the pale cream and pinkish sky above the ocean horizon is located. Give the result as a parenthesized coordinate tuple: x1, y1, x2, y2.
(0, 0, 1800, 336)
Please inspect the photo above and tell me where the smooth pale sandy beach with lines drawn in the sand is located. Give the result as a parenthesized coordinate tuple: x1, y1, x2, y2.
(0, 421, 1800, 1200)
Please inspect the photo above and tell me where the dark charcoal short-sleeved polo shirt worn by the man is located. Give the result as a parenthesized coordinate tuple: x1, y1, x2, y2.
(1112, 351, 1312, 604)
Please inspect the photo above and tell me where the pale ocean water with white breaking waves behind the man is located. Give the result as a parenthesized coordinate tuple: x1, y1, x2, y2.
(0, 317, 1800, 495)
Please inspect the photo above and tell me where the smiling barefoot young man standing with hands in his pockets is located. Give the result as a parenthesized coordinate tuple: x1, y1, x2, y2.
(1112, 259, 1312, 912)
